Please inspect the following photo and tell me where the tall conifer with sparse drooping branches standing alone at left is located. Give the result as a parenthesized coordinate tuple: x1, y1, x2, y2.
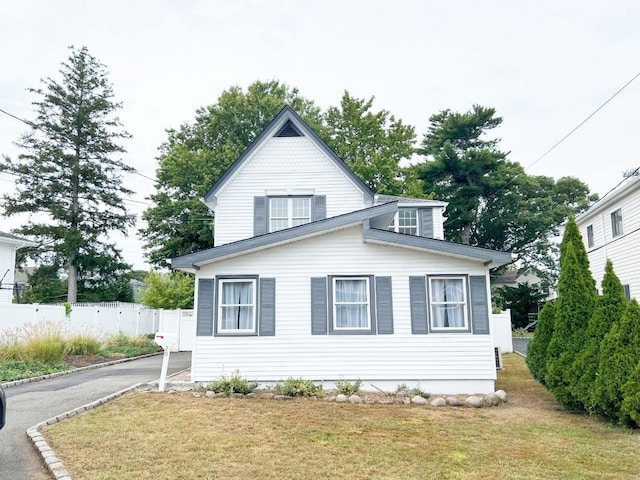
(0, 47, 134, 302)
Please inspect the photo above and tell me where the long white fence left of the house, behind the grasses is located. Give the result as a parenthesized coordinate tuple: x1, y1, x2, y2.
(0, 302, 195, 351)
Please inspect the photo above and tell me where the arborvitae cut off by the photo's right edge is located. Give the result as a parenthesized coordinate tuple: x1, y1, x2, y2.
(594, 299, 640, 424)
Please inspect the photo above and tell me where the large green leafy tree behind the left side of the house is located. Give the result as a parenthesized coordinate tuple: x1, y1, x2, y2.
(140, 80, 322, 266)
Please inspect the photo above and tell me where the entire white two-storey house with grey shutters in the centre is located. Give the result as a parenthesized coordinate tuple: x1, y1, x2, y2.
(172, 107, 511, 393)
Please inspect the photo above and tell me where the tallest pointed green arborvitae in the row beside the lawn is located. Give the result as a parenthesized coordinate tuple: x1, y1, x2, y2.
(545, 218, 597, 410)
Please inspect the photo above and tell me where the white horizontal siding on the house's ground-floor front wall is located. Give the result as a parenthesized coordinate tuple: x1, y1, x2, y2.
(192, 226, 495, 393)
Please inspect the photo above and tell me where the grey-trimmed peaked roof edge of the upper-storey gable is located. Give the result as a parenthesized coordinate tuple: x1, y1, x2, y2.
(203, 105, 373, 208)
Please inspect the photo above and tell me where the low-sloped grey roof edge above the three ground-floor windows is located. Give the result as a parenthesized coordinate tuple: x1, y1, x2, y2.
(171, 202, 511, 271)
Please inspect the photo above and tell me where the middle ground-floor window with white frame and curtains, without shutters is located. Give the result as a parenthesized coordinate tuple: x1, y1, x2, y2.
(333, 277, 371, 330)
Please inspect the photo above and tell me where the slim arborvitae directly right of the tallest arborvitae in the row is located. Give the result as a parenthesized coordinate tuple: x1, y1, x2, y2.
(570, 260, 627, 414)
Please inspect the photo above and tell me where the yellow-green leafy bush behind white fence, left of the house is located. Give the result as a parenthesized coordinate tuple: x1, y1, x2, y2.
(141, 272, 194, 310)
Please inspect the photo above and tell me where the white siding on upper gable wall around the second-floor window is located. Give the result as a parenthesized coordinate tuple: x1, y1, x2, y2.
(214, 137, 369, 246)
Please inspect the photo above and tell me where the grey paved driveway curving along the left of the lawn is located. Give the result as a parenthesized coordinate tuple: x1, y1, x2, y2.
(0, 352, 191, 480)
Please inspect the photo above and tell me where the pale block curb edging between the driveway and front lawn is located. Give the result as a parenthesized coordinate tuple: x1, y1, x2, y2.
(27, 382, 147, 480)
